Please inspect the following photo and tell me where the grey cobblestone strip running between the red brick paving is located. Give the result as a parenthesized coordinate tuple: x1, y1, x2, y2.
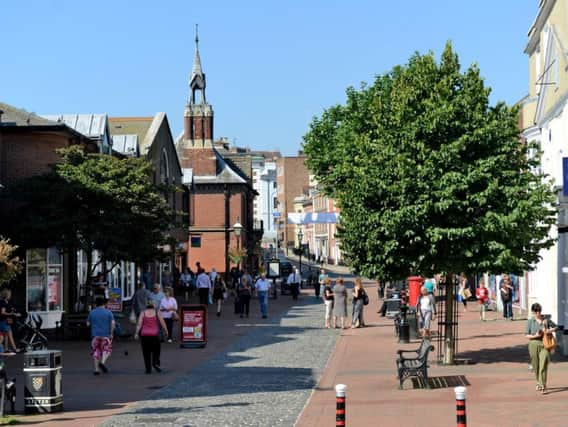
(103, 296, 338, 427)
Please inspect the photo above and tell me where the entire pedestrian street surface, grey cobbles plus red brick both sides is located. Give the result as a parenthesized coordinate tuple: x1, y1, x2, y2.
(8, 258, 568, 427)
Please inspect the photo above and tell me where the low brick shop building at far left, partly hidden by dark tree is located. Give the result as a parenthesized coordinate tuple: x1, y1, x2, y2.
(0, 103, 99, 327)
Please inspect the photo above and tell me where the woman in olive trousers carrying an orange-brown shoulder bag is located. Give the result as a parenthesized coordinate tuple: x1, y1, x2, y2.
(525, 303, 558, 394)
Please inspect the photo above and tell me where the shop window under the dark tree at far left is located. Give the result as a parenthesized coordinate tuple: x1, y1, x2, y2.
(26, 248, 63, 311)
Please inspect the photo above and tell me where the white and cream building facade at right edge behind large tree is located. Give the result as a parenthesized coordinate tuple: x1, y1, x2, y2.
(521, 0, 568, 325)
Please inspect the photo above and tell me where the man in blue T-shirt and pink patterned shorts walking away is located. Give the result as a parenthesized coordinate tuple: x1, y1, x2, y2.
(87, 298, 116, 375)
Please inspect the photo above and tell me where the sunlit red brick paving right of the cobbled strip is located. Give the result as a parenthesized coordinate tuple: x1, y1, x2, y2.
(296, 283, 568, 427)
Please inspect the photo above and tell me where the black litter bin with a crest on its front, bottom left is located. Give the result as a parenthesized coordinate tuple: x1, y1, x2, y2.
(24, 350, 63, 414)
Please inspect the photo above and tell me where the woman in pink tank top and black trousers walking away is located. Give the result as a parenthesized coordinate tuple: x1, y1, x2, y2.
(134, 300, 168, 374)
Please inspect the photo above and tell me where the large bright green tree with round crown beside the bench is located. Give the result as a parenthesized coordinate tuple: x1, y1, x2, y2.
(304, 43, 555, 363)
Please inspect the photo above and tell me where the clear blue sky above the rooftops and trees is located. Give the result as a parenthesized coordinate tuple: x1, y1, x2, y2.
(0, 0, 538, 155)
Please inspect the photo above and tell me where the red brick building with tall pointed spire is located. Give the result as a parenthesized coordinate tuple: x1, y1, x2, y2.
(177, 31, 256, 272)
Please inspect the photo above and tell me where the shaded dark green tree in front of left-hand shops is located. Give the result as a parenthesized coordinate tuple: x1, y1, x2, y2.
(5, 146, 175, 290)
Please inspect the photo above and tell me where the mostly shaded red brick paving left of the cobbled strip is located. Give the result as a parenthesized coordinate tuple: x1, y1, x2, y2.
(5, 280, 302, 427)
